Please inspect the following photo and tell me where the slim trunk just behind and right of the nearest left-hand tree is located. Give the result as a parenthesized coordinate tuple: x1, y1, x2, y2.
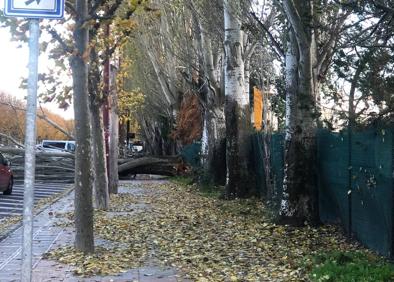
(90, 100, 109, 210)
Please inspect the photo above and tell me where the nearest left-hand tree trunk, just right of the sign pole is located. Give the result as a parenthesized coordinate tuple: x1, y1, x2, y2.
(70, 0, 94, 253)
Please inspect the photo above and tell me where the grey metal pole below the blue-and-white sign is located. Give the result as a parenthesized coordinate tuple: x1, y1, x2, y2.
(21, 19, 40, 282)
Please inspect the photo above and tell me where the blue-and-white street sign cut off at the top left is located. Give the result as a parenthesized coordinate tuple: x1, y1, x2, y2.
(4, 0, 64, 19)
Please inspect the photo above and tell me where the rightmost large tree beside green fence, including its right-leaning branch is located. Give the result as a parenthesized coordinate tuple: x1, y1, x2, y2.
(276, 0, 349, 224)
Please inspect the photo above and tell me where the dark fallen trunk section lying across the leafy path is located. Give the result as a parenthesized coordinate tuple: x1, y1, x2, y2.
(118, 156, 186, 176)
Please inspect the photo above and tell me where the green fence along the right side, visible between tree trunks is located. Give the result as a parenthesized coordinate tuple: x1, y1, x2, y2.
(253, 127, 394, 256)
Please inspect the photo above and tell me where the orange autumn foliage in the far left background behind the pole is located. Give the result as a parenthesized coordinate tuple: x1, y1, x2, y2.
(0, 92, 74, 141)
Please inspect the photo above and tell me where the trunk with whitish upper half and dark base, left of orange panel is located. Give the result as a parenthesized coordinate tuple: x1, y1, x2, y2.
(224, 0, 252, 198)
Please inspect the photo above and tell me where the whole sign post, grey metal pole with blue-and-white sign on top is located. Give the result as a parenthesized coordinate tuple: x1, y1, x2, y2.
(4, 0, 64, 282)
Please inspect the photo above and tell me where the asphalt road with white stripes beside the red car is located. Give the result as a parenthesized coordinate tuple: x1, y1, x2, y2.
(0, 183, 70, 218)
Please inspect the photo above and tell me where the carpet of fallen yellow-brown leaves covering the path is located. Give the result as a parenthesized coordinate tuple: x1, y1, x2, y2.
(49, 183, 372, 281)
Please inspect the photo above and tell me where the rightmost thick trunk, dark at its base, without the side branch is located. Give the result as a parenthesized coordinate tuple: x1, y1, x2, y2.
(280, 0, 319, 225)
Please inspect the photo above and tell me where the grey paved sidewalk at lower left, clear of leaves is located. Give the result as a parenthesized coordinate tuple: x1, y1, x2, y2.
(0, 182, 181, 282)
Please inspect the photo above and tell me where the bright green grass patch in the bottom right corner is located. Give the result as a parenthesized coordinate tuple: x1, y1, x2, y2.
(309, 251, 394, 282)
